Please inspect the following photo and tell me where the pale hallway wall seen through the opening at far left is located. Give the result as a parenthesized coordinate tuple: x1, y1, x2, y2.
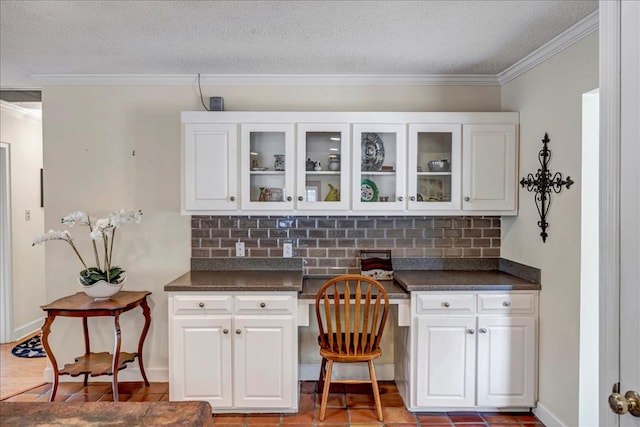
(0, 105, 46, 340)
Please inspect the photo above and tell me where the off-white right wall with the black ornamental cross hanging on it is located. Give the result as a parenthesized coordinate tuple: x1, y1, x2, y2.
(502, 33, 598, 426)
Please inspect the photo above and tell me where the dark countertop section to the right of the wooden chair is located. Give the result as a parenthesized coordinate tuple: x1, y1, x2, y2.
(394, 270, 540, 292)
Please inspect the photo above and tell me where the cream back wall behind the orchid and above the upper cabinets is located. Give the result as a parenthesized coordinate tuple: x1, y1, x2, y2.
(43, 86, 500, 381)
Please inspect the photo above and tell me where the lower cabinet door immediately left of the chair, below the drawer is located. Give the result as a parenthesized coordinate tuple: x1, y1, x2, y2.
(233, 316, 298, 408)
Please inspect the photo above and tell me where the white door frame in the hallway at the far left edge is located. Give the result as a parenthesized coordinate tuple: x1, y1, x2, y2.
(0, 142, 13, 344)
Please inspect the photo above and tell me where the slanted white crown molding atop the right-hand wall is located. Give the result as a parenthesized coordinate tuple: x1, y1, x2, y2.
(497, 10, 599, 86)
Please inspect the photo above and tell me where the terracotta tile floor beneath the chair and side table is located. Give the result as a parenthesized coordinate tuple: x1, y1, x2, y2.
(5, 381, 544, 427)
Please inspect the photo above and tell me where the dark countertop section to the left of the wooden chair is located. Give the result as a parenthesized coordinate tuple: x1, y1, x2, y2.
(164, 270, 303, 292)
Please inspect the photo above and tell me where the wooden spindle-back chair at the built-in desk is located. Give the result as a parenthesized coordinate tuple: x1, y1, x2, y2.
(315, 274, 389, 421)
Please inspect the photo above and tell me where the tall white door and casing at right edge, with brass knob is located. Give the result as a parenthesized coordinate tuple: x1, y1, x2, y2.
(599, 1, 640, 427)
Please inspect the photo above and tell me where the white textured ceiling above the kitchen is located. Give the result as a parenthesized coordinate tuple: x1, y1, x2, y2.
(0, 0, 598, 88)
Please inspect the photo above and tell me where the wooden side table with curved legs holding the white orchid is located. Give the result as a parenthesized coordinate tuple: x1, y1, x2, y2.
(42, 291, 151, 402)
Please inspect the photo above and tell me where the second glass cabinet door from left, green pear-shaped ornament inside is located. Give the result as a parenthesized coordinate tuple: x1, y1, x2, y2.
(296, 123, 351, 211)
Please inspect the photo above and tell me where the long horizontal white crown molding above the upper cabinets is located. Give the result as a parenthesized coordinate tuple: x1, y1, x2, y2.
(31, 74, 499, 86)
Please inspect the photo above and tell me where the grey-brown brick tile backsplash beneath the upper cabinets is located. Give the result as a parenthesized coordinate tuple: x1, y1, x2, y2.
(191, 216, 500, 275)
